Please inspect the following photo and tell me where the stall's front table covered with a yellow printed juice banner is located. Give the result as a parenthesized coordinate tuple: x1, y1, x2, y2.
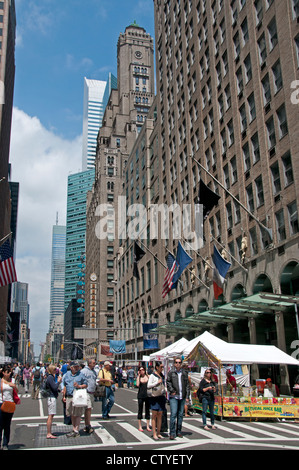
(192, 392, 299, 419)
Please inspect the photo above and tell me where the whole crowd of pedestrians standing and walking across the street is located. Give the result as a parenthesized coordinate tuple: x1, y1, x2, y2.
(0, 357, 225, 449)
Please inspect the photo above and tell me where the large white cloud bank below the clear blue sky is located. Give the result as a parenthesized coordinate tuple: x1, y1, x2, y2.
(10, 108, 82, 354)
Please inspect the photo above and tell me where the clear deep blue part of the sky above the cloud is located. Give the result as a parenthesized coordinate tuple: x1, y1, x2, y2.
(14, 0, 154, 138)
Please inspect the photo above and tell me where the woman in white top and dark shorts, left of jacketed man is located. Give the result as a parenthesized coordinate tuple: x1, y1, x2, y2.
(147, 362, 166, 441)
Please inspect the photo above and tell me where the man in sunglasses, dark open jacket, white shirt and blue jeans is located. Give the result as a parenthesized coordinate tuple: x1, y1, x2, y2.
(166, 357, 190, 439)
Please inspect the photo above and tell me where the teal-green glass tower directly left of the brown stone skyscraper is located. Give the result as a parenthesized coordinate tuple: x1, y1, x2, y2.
(64, 168, 95, 310)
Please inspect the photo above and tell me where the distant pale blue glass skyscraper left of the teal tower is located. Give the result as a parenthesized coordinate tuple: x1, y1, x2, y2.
(49, 225, 66, 333)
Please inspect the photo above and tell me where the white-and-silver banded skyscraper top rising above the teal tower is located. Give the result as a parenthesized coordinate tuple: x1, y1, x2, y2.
(82, 77, 106, 171)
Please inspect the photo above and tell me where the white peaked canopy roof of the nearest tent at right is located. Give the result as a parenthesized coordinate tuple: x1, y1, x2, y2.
(186, 331, 299, 366)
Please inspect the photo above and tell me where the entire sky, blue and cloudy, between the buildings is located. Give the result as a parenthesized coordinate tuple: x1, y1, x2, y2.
(10, 0, 154, 355)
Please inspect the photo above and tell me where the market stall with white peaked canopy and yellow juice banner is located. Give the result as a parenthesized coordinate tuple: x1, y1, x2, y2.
(186, 331, 299, 418)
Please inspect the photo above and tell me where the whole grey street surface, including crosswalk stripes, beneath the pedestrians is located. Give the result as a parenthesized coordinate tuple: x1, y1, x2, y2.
(5, 387, 299, 454)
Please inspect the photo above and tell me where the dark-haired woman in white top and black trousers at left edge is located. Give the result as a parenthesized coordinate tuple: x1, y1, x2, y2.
(0, 366, 18, 450)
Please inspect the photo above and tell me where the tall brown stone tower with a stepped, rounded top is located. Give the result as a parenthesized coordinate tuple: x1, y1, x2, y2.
(85, 23, 154, 352)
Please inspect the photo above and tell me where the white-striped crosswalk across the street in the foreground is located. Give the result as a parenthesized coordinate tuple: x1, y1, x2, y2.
(14, 395, 299, 451)
